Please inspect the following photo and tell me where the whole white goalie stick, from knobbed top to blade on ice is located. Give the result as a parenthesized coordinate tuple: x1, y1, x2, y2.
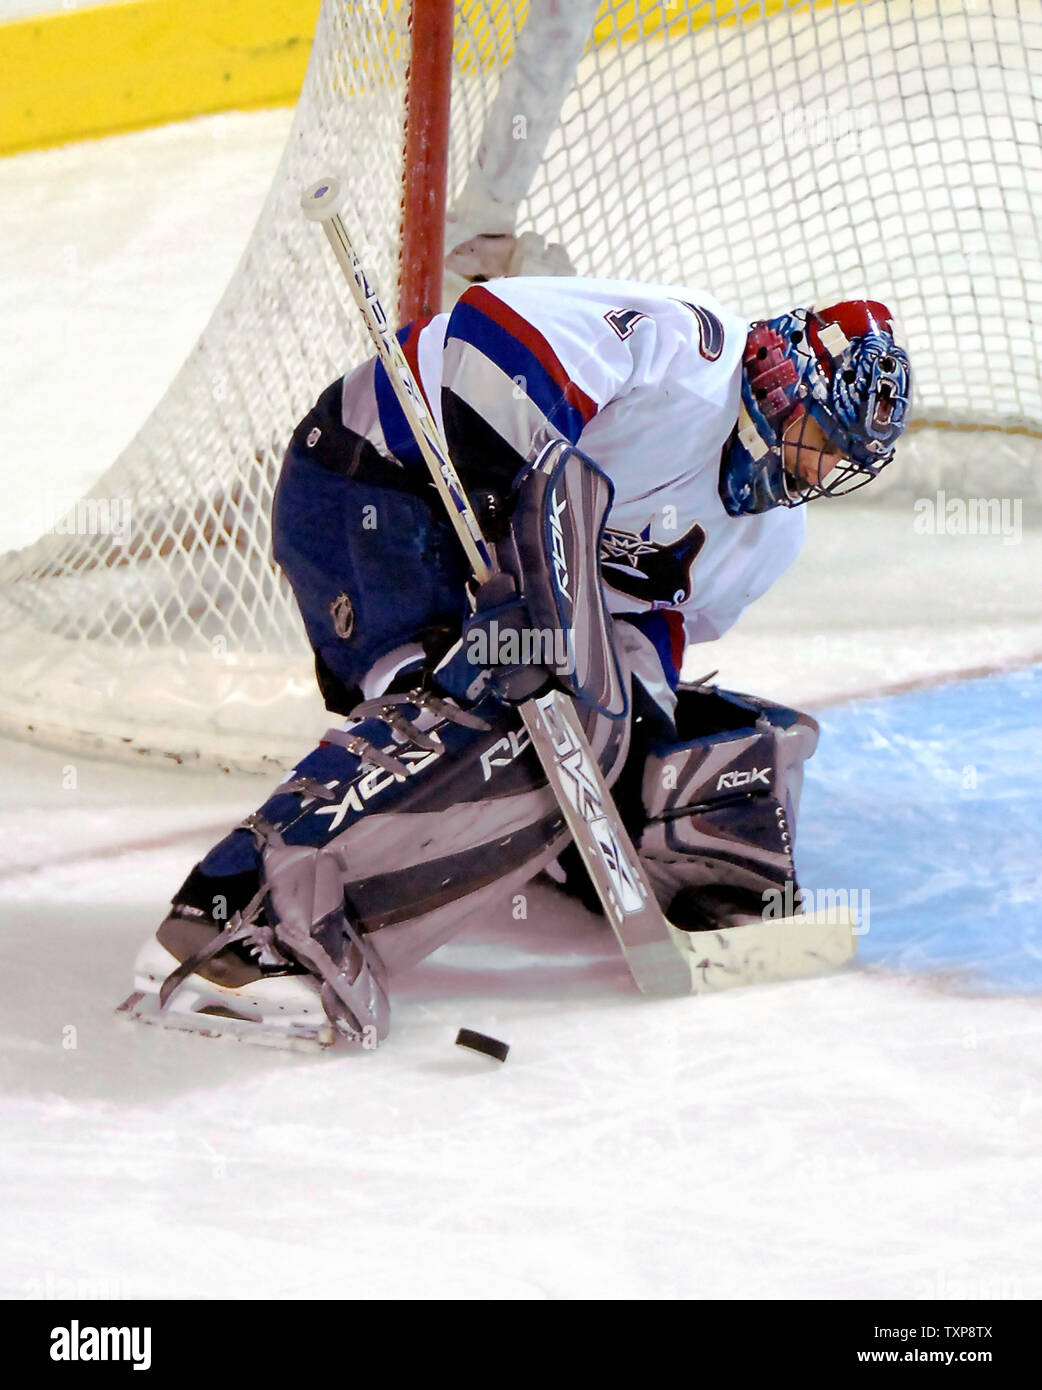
(300, 178, 853, 995)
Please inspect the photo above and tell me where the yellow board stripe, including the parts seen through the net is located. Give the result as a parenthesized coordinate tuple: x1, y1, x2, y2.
(0, 0, 864, 154)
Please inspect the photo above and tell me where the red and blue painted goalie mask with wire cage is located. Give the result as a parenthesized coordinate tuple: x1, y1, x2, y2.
(720, 299, 911, 516)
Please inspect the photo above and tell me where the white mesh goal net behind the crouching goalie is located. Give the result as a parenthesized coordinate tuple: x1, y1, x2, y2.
(0, 0, 1042, 769)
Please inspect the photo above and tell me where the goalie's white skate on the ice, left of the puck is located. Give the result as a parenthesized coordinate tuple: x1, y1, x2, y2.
(115, 924, 338, 1052)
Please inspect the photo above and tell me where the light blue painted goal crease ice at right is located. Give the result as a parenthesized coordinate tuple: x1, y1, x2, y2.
(799, 667, 1042, 995)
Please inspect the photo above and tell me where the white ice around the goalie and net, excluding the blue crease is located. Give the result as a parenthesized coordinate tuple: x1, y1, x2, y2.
(0, 113, 1042, 1298)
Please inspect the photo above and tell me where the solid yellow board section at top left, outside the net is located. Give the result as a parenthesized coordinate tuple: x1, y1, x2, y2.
(0, 0, 320, 154)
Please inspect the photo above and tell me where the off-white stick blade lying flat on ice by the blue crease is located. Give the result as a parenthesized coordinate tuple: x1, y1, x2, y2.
(670, 908, 857, 994)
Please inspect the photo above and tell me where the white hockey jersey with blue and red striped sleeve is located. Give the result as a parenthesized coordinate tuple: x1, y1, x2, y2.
(343, 278, 804, 666)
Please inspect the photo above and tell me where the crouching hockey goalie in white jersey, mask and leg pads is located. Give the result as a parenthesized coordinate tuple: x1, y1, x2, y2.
(118, 277, 910, 1043)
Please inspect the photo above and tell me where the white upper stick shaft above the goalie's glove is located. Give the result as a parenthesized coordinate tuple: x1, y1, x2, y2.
(300, 178, 496, 584)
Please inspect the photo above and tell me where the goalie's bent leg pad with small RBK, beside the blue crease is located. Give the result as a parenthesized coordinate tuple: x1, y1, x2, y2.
(640, 687, 818, 930)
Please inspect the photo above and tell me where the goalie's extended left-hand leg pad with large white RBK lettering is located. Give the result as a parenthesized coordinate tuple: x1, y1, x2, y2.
(161, 675, 629, 1011)
